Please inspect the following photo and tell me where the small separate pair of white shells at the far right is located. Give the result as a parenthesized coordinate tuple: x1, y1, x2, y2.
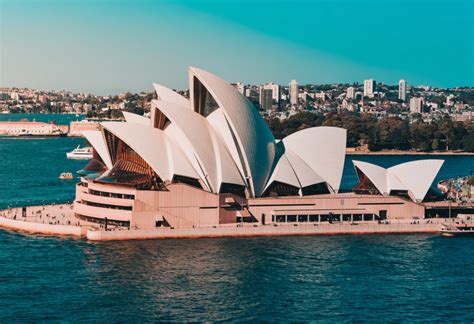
(352, 160, 444, 201)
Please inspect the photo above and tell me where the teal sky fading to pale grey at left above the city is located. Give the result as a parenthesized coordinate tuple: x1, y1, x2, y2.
(0, 0, 474, 95)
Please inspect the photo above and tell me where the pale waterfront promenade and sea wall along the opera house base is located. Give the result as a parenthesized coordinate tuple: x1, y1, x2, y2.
(0, 204, 470, 241)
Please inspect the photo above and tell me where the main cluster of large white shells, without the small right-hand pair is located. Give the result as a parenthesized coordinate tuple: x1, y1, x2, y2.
(96, 67, 352, 197)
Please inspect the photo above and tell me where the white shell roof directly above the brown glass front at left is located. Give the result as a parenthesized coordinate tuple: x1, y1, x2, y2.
(101, 122, 199, 181)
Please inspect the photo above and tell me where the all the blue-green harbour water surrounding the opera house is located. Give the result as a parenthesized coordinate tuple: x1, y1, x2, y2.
(0, 115, 474, 323)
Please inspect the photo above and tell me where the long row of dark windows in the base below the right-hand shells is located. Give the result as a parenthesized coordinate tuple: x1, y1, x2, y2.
(272, 214, 378, 223)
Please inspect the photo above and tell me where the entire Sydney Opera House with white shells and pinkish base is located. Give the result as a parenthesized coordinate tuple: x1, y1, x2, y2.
(74, 67, 442, 229)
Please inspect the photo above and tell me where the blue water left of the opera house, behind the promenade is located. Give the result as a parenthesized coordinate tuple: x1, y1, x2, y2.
(0, 137, 87, 209)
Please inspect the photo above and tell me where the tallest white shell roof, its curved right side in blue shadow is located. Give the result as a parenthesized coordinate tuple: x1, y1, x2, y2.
(189, 67, 276, 196)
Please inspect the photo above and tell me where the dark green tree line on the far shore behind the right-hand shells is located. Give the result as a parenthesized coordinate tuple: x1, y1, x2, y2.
(267, 112, 474, 152)
